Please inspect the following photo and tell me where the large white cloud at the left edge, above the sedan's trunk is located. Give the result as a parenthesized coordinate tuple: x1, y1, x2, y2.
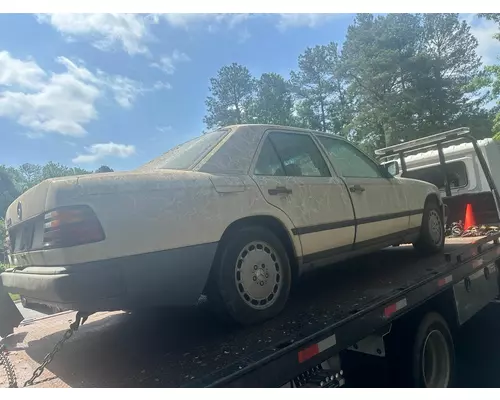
(0, 51, 166, 137)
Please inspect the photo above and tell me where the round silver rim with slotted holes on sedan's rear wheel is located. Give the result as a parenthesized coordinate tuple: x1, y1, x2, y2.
(234, 241, 282, 310)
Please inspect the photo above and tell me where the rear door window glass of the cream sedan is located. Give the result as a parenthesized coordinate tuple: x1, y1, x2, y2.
(255, 132, 331, 177)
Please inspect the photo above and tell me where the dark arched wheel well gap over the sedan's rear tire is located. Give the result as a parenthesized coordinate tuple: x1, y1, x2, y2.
(212, 219, 299, 283)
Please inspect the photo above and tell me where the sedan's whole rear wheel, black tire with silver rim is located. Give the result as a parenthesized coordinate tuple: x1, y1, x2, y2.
(207, 226, 292, 325)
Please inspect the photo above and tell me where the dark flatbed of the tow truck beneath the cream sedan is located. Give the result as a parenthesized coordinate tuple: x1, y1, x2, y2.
(0, 236, 500, 387)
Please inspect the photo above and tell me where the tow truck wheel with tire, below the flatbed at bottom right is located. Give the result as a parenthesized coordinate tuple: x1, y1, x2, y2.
(412, 312, 455, 388)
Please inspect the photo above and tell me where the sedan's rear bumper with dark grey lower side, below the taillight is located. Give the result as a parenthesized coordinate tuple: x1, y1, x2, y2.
(0, 243, 217, 311)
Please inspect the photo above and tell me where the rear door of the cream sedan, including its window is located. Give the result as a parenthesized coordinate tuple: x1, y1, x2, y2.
(252, 131, 355, 262)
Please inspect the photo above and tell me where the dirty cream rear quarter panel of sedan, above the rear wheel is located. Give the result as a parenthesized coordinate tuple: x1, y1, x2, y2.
(35, 172, 301, 265)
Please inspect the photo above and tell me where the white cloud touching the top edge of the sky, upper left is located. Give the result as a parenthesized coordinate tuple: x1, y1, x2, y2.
(37, 13, 154, 55)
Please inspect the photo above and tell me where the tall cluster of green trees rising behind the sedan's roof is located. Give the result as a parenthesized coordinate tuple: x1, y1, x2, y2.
(204, 14, 500, 147)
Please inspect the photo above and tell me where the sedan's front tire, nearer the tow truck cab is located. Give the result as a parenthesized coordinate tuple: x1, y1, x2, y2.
(413, 200, 444, 255)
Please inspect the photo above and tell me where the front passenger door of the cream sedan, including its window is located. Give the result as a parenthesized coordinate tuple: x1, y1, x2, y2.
(316, 135, 410, 247)
